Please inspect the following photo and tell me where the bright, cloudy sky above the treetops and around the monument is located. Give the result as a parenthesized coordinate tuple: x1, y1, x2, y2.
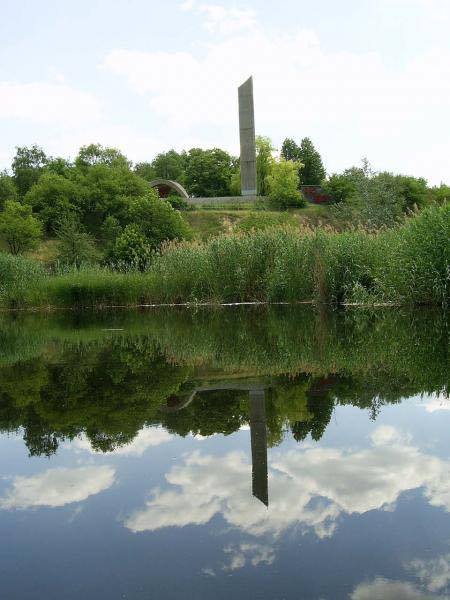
(0, 0, 450, 184)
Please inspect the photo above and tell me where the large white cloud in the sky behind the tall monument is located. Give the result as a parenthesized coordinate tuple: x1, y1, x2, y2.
(103, 8, 450, 182)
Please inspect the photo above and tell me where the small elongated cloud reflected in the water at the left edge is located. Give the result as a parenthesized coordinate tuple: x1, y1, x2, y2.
(0, 466, 115, 509)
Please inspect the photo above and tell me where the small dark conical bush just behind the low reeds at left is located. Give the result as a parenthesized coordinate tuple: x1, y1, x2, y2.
(56, 217, 99, 269)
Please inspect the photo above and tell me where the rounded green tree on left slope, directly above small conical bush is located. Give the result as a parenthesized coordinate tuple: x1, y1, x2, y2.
(24, 172, 84, 234)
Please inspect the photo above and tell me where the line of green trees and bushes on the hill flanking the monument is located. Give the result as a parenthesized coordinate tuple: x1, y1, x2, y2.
(0, 136, 444, 268)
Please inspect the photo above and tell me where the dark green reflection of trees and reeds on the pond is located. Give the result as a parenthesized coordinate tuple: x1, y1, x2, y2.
(0, 307, 448, 458)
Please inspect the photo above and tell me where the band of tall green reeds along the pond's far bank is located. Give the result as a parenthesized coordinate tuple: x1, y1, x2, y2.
(0, 204, 450, 308)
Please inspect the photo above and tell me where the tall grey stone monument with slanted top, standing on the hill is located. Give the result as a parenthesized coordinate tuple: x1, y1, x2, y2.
(238, 77, 257, 196)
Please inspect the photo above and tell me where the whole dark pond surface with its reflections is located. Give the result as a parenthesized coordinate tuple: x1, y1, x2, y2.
(0, 307, 450, 600)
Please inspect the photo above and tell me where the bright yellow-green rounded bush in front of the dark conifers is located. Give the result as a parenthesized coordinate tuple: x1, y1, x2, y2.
(267, 158, 304, 209)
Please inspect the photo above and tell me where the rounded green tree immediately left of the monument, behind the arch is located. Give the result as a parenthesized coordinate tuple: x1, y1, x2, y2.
(185, 148, 236, 198)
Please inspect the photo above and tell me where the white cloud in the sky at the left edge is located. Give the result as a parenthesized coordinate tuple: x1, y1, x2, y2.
(0, 81, 101, 126)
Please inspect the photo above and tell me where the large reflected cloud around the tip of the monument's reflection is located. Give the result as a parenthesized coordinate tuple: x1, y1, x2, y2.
(125, 428, 450, 538)
